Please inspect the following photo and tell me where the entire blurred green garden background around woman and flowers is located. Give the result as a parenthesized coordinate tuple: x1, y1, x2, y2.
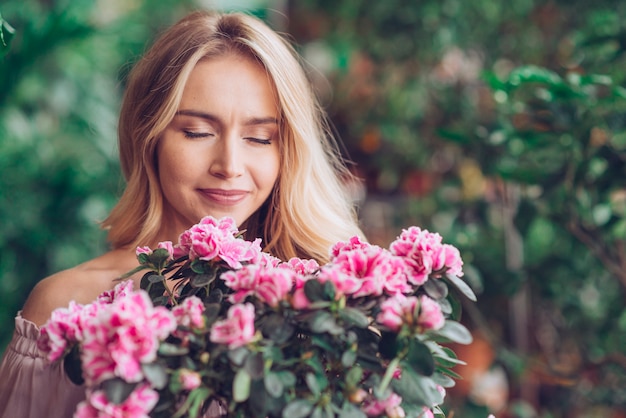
(0, 0, 626, 418)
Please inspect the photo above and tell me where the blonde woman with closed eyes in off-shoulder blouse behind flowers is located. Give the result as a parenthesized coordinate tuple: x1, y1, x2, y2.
(0, 12, 362, 418)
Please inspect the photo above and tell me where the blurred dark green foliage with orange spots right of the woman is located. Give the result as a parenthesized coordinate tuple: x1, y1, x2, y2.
(289, 0, 626, 418)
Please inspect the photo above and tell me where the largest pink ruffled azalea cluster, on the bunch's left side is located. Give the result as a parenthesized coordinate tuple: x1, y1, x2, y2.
(81, 291, 176, 385)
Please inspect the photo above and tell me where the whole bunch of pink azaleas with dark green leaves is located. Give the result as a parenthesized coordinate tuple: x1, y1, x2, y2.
(39, 217, 475, 418)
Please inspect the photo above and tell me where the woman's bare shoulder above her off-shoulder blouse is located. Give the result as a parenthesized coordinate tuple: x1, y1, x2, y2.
(22, 250, 136, 326)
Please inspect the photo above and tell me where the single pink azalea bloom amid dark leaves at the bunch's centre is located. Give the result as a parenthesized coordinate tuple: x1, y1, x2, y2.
(209, 303, 255, 350)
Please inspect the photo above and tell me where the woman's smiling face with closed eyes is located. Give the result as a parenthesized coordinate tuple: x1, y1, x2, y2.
(157, 54, 280, 234)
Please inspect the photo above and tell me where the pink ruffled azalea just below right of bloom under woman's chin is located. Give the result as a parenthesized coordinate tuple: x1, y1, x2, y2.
(221, 264, 296, 307)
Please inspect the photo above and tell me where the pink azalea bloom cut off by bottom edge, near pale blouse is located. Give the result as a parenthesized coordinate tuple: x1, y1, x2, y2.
(74, 385, 159, 418)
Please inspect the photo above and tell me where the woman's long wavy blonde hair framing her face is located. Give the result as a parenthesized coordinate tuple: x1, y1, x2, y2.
(103, 12, 362, 262)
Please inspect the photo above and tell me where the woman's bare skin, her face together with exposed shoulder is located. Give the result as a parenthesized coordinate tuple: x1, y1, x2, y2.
(22, 54, 280, 326)
